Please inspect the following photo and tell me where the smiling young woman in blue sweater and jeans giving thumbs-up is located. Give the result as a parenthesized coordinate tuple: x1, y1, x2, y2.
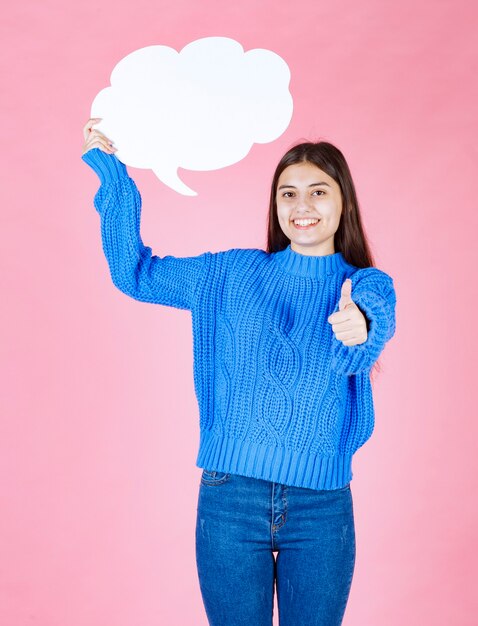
(82, 114, 396, 626)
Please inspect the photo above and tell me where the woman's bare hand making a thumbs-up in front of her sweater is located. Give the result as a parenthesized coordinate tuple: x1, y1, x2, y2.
(327, 278, 368, 346)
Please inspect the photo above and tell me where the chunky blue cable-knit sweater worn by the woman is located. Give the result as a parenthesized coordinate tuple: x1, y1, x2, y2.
(82, 148, 396, 489)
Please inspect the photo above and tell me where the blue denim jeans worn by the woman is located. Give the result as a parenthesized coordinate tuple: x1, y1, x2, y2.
(196, 469, 355, 626)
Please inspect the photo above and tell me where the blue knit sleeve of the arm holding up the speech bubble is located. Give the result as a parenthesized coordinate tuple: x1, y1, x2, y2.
(81, 148, 211, 310)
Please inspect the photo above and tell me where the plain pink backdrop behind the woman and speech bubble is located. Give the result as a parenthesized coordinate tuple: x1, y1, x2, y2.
(0, 0, 478, 626)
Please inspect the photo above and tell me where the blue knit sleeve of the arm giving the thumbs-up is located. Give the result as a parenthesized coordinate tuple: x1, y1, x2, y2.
(332, 267, 396, 375)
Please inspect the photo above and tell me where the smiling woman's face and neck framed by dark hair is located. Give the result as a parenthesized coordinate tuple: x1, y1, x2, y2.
(276, 162, 342, 256)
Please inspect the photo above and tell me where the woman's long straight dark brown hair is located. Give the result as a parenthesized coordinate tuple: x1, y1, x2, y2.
(266, 141, 381, 378)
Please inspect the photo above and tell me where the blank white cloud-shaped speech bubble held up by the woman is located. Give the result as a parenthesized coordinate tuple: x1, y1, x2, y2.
(91, 37, 293, 196)
